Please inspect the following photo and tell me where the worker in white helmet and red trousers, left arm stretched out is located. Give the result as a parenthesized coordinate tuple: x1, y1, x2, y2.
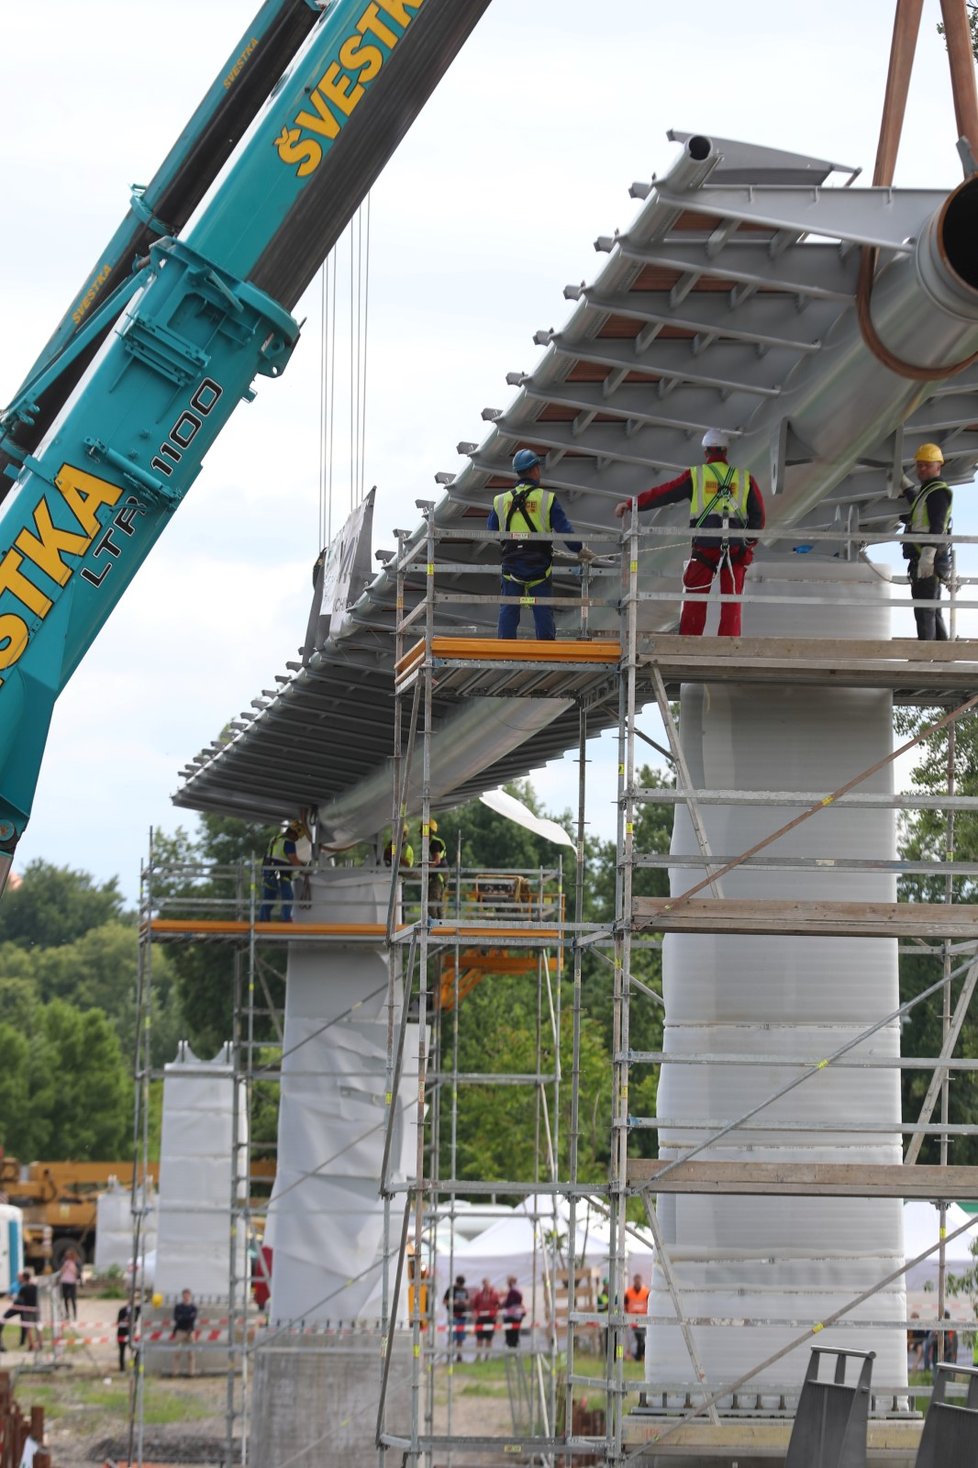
(615, 429, 764, 637)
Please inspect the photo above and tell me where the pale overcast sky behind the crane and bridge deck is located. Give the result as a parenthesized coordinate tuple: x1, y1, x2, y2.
(0, 0, 972, 898)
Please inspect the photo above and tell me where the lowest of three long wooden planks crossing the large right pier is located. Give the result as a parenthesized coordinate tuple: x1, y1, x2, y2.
(629, 1157, 978, 1197)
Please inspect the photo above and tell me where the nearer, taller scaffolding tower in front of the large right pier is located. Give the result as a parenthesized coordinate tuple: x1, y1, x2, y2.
(372, 512, 978, 1464)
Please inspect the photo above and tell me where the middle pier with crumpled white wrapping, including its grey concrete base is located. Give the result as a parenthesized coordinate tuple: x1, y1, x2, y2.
(251, 868, 419, 1465)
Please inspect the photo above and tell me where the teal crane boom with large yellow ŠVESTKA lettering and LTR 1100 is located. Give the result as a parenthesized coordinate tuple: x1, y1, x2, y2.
(0, 0, 489, 890)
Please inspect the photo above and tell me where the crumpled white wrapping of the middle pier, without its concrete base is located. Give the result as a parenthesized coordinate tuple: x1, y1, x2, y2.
(266, 868, 417, 1327)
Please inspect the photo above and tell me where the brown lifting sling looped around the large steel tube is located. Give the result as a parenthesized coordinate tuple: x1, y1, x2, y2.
(856, 0, 978, 382)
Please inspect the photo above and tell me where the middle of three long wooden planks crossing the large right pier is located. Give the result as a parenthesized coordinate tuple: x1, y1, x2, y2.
(631, 897, 978, 941)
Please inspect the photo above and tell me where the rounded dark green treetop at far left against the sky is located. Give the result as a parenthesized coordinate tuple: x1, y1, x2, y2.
(0, 860, 122, 948)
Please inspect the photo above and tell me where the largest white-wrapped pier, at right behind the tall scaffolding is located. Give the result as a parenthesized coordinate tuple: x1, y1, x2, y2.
(646, 561, 906, 1406)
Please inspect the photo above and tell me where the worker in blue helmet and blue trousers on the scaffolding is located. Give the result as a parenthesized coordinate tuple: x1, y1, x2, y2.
(486, 449, 593, 642)
